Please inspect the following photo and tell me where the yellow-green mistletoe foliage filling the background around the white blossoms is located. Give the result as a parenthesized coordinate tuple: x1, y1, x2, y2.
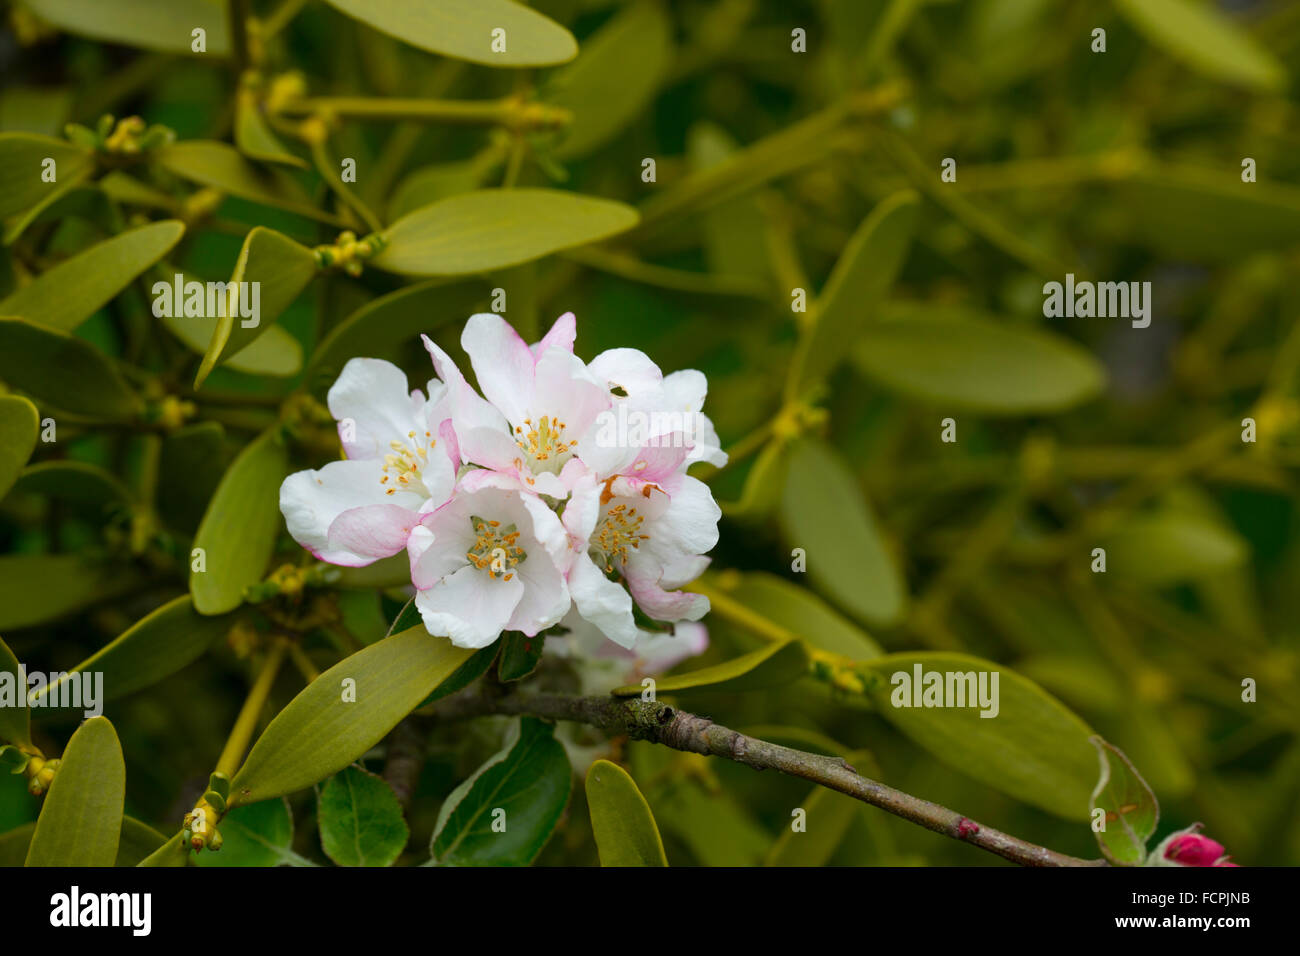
(0, 0, 1300, 865)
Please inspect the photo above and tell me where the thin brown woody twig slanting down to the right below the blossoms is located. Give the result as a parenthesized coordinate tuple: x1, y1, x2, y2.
(433, 691, 1106, 866)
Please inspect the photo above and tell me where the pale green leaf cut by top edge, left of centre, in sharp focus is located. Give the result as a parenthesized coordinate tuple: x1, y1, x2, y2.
(318, 0, 577, 66)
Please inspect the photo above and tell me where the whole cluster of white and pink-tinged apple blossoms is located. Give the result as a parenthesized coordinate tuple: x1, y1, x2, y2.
(280, 312, 727, 658)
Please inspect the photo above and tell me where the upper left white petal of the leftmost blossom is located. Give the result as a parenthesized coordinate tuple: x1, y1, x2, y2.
(326, 359, 417, 459)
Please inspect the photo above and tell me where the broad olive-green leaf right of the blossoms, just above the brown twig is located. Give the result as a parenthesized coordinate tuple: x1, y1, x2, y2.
(865, 652, 1097, 819)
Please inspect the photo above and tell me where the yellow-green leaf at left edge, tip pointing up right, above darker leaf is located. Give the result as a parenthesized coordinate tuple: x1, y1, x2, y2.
(0, 220, 185, 332)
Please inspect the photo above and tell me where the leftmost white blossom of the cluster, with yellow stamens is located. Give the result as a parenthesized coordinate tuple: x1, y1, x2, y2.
(280, 359, 460, 567)
